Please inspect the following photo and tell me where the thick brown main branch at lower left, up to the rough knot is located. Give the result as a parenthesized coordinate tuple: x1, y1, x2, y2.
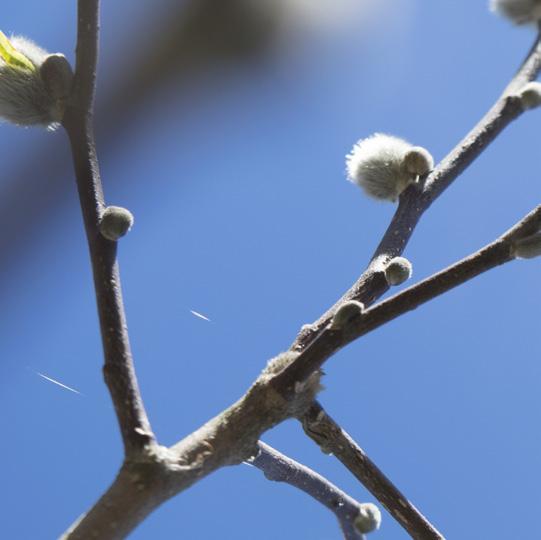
(63, 360, 322, 540)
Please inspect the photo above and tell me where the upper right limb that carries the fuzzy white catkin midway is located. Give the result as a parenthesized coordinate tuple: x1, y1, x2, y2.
(291, 30, 541, 351)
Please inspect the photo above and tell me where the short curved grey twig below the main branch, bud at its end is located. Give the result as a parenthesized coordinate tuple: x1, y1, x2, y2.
(248, 441, 363, 540)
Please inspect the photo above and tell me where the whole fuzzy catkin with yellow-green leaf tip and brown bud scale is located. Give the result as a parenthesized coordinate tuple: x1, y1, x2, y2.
(0, 32, 71, 129)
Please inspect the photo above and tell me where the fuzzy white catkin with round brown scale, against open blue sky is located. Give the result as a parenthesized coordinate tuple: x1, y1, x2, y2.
(346, 133, 433, 201)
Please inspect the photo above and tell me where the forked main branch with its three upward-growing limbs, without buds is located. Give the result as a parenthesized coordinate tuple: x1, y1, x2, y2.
(63, 5, 541, 540)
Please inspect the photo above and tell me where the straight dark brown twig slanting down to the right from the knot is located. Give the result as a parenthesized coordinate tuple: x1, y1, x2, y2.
(302, 401, 444, 540)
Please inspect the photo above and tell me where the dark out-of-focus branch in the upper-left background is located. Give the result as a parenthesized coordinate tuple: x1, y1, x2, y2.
(0, 0, 280, 286)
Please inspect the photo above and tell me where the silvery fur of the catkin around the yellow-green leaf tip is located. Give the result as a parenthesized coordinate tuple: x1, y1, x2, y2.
(0, 36, 63, 129)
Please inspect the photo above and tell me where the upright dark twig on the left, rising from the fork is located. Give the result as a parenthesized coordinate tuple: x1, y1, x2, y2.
(63, 0, 154, 455)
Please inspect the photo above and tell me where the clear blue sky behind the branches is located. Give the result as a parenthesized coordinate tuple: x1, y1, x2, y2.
(0, 0, 541, 540)
